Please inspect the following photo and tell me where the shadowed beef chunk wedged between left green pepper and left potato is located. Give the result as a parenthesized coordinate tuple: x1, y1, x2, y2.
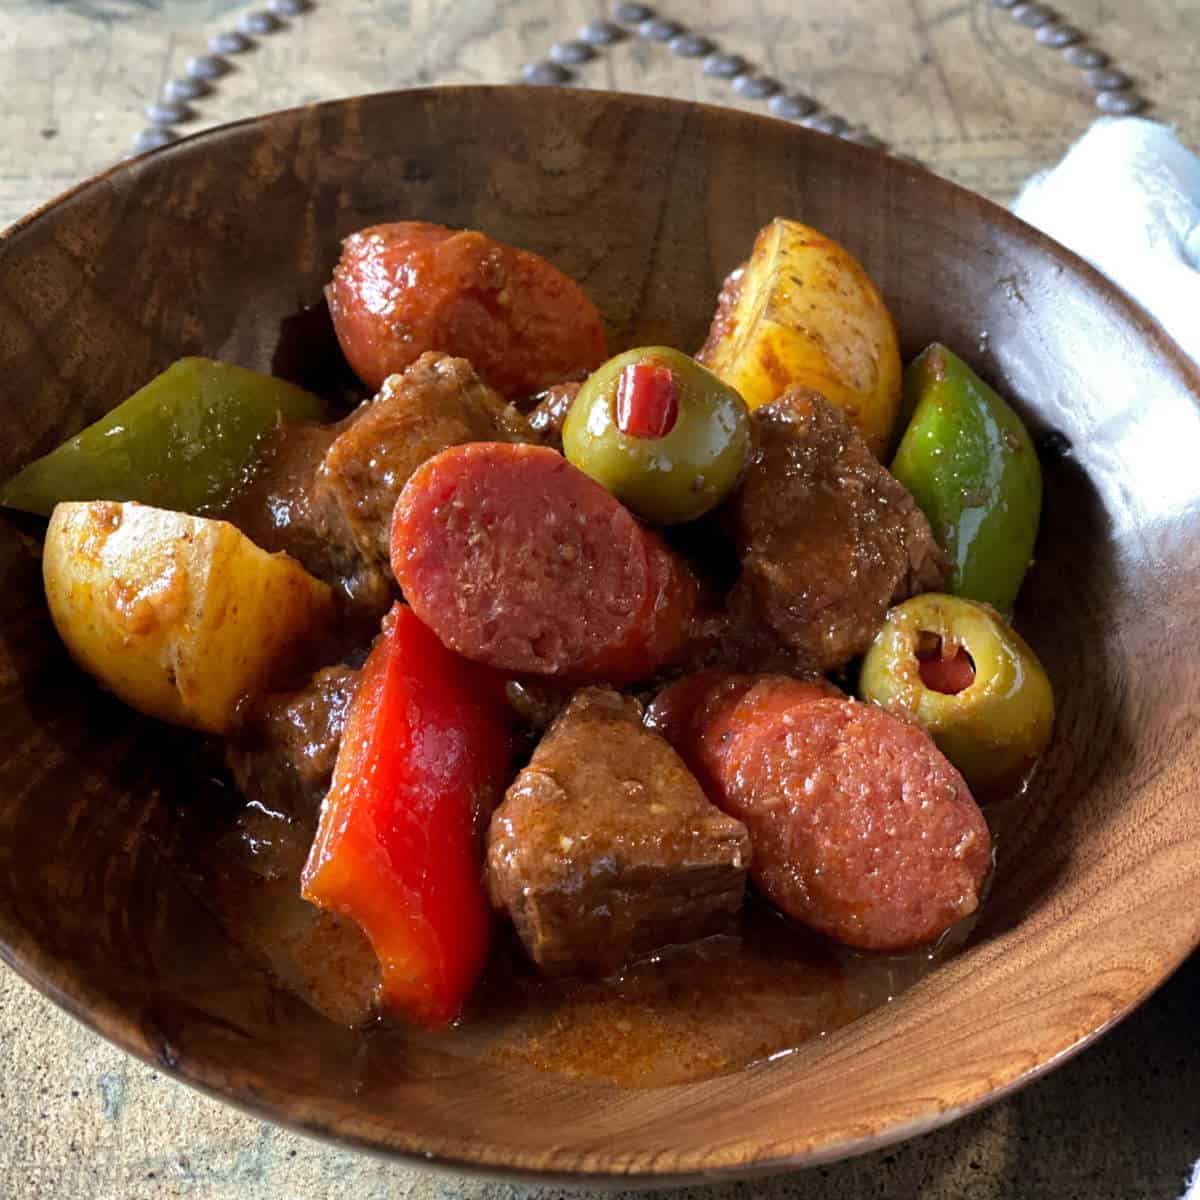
(227, 416, 394, 625)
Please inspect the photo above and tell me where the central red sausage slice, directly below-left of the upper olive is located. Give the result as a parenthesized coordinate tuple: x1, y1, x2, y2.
(391, 442, 697, 683)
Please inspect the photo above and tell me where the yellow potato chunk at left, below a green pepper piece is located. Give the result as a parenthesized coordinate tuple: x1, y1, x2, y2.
(42, 500, 332, 733)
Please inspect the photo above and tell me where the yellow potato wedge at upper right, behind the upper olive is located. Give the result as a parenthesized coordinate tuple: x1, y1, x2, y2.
(696, 217, 900, 457)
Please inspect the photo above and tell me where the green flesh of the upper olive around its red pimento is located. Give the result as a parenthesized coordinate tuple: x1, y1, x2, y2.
(563, 346, 751, 524)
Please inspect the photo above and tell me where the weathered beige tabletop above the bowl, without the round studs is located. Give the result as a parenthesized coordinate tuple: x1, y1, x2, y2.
(7, 0, 1200, 223)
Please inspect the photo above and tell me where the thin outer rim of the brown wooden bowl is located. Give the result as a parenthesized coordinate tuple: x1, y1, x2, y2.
(0, 84, 1200, 1190)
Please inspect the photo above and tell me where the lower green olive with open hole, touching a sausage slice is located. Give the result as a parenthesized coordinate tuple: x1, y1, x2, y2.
(858, 593, 1054, 793)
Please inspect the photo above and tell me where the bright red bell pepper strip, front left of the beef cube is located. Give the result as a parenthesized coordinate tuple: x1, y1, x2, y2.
(301, 605, 510, 1028)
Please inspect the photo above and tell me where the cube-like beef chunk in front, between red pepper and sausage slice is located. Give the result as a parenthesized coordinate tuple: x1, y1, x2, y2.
(487, 688, 750, 974)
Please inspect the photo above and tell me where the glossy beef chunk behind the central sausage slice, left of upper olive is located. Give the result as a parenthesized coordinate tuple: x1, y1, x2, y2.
(320, 352, 536, 568)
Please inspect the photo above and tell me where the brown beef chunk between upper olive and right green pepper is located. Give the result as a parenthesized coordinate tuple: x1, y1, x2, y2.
(731, 388, 943, 671)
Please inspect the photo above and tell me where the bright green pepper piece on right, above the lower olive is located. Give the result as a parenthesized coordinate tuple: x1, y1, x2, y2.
(892, 342, 1042, 613)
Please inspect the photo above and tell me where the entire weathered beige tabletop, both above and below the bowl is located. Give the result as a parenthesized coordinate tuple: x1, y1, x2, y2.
(0, 0, 1200, 1200)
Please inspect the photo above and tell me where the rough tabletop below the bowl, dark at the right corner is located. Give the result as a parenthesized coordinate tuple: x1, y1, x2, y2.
(0, 956, 1200, 1200)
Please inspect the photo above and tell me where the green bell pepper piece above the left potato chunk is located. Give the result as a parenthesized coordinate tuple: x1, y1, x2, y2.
(0, 358, 325, 517)
